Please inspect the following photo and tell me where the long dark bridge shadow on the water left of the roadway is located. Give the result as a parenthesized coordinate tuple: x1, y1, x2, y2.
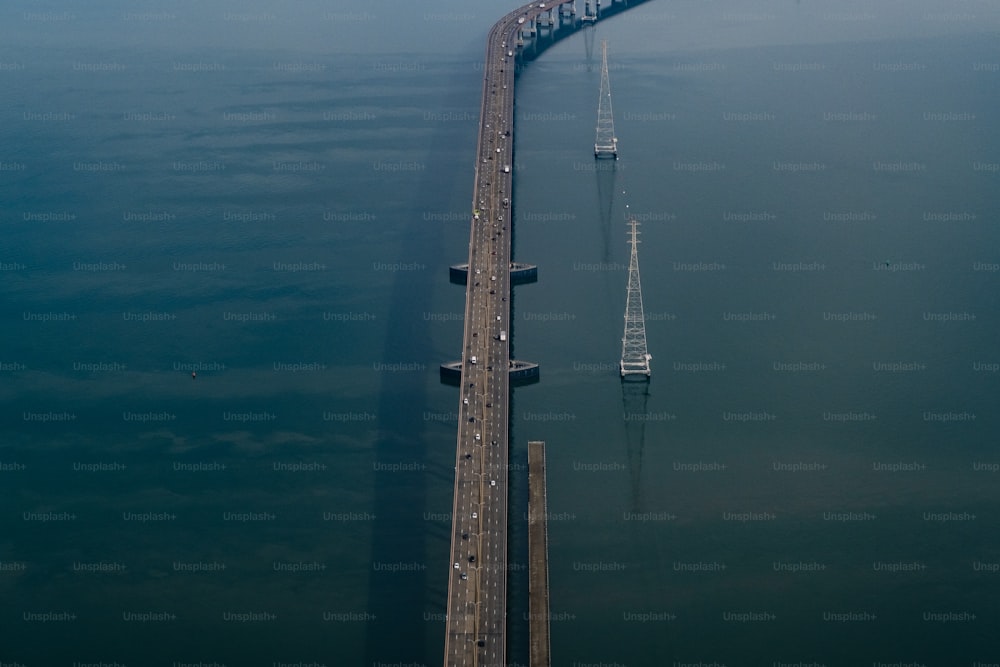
(364, 66, 481, 665)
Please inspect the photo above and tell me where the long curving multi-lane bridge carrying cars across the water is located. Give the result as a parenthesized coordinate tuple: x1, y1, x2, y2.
(442, 0, 643, 667)
